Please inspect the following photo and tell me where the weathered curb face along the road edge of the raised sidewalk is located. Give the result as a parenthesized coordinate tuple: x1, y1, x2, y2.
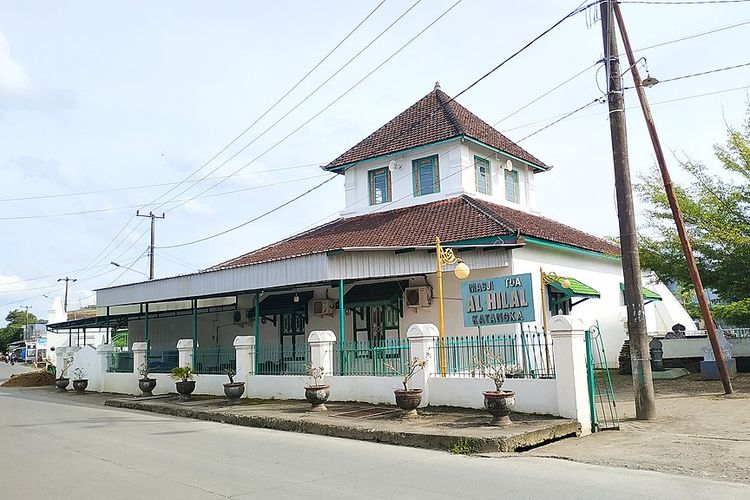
(104, 399, 579, 453)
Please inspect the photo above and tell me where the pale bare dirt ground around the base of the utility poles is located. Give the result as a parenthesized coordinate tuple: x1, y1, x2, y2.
(527, 372, 750, 484)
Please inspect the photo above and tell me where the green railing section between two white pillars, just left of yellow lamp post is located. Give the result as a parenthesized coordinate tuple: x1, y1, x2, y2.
(333, 340, 409, 377)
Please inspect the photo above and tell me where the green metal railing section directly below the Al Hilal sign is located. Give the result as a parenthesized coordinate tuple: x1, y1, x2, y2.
(434, 331, 555, 378)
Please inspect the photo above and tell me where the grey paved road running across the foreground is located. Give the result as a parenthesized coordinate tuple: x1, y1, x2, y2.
(0, 370, 750, 500)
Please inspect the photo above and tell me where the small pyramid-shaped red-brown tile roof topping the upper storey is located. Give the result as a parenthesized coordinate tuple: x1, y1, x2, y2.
(324, 86, 549, 170)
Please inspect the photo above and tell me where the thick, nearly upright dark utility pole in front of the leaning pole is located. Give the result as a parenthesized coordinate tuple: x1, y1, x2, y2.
(600, 0, 656, 420)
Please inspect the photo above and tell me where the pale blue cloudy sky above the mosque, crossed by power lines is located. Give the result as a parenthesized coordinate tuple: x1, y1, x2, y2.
(0, 0, 750, 318)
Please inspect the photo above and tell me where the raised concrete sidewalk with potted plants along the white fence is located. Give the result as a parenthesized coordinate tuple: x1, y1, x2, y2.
(103, 395, 579, 453)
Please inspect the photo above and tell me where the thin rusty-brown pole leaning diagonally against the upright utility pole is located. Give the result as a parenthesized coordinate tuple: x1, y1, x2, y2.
(614, 3, 733, 394)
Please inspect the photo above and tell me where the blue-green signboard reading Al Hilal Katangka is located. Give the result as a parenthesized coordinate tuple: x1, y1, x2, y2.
(461, 273, 534, 327)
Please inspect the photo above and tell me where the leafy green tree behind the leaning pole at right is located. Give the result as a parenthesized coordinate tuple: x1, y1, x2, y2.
(637, 107, 750, 326)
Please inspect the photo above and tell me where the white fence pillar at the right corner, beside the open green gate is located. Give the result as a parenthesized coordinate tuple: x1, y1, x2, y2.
(549, 315, 591, 435)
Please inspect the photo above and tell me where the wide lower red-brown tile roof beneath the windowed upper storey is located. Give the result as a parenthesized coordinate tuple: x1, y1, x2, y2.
(213, 195, 620, 271)
